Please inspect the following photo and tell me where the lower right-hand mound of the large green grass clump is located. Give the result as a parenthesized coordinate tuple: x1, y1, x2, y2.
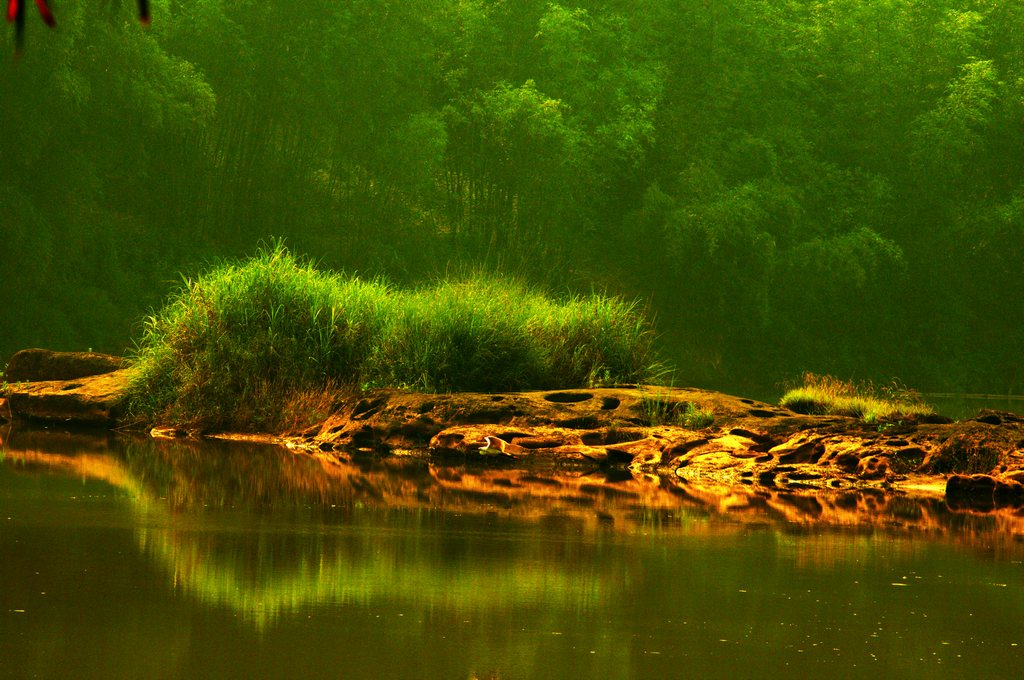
(368, 274, 655, 391)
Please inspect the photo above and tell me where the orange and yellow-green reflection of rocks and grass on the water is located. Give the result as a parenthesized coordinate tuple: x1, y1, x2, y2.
(6, 434, 1024, 614)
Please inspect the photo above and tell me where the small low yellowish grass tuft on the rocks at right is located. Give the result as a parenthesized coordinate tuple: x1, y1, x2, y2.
(780, 373, 935, 423)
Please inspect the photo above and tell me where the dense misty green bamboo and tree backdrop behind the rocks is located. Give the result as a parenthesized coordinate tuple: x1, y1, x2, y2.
(0, 0, 1024, 392)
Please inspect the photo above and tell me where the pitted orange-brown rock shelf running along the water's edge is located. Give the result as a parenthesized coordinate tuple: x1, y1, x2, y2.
(6, 350, 1024, 512)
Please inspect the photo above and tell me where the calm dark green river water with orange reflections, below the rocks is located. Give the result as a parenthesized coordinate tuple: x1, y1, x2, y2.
(0, 432, 1024, 679)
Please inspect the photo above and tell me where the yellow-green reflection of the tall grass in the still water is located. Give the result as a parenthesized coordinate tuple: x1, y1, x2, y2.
(138, 512, 614, 628)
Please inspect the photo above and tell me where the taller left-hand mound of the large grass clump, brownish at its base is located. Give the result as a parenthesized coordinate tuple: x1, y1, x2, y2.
(129, 244, 394, 427)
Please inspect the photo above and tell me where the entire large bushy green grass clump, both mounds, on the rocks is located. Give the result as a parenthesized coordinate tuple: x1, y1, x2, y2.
(123, 244, 657, 428)
